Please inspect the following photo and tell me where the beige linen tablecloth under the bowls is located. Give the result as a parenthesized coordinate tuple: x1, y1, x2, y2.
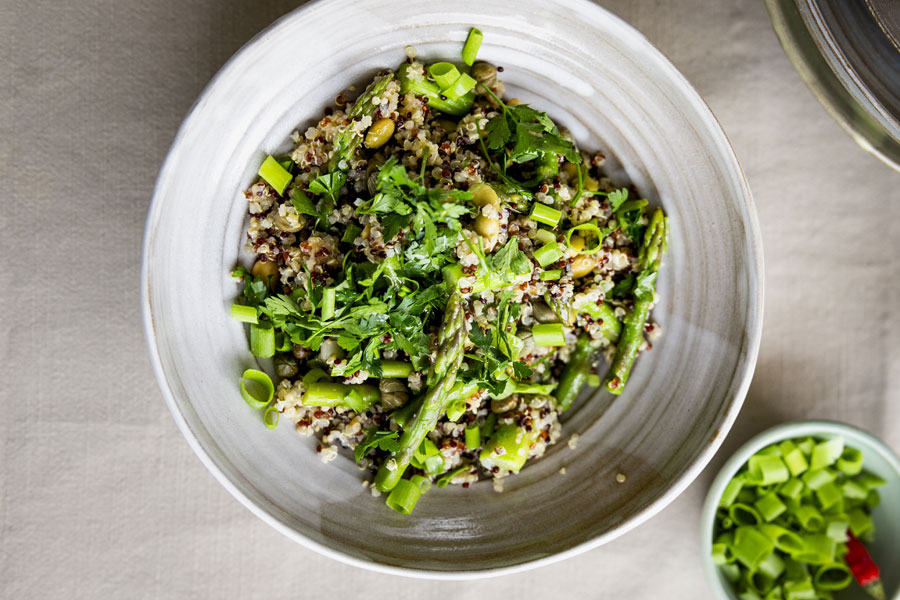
(0, 0, 900, 600)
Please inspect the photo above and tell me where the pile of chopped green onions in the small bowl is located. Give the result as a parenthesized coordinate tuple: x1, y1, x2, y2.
(712, 437, 884, 600)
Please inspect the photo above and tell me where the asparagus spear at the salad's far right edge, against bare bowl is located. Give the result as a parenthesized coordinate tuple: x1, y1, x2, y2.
(603, 208, 666, 395)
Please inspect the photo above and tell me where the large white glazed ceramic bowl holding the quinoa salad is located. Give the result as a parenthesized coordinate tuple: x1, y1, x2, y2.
(143, 0, 763, 578)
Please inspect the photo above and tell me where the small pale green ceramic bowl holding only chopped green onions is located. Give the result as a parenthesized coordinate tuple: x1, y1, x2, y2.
(700, 421, 900, 600)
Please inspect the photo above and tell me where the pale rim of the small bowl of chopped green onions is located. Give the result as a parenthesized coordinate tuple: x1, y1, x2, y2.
(700, 419, 900, 600)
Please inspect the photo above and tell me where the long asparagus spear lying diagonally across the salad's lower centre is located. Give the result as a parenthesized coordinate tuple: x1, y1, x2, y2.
(375, 294, 466, 492)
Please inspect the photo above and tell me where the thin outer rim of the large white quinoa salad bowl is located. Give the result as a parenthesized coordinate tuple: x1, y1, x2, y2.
(140, 0, 765, 580)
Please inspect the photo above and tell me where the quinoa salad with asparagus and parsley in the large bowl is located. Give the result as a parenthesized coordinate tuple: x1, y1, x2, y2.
(231, 29, 666, 514)
